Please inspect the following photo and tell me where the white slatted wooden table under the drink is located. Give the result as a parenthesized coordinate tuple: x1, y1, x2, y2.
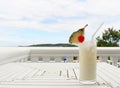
(0, 62, 120, 88)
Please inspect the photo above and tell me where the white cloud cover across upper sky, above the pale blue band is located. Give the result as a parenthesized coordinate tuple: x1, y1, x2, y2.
(0, 0, 120, 45)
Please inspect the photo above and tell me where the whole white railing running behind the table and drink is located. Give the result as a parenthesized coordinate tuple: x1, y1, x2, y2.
(0, 47, 120, 65)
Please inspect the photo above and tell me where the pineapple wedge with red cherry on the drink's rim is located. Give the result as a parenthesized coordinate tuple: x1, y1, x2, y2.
(69, 24, 88, 44)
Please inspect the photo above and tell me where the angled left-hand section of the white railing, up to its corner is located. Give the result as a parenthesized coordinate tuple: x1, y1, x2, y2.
(0, 47, 30, 65)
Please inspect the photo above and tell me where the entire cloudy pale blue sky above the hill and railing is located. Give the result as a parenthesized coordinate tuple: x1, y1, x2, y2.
(0, 0, 120, 46)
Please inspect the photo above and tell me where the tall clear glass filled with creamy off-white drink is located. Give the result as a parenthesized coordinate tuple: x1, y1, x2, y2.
(79, 41, 97, 84)
